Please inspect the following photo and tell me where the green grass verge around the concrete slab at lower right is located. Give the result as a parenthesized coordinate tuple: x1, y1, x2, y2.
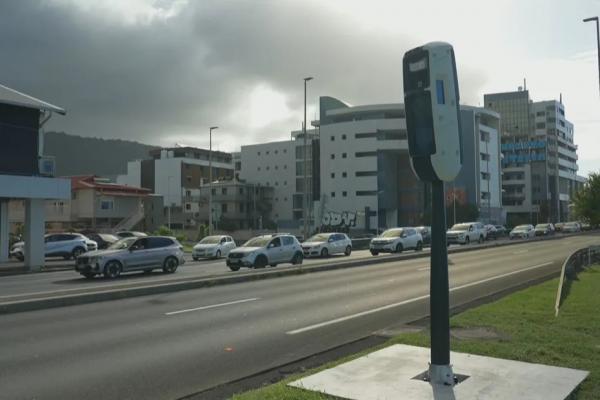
(233, 267, 600, 400)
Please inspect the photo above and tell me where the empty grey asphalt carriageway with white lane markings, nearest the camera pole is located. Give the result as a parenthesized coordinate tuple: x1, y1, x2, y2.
(0, 236, 600, 399)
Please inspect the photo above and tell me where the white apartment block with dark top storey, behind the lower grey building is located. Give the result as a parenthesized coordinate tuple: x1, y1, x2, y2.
(117, 147, 234, 229)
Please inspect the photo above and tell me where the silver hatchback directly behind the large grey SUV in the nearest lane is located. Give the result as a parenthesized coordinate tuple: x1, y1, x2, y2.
(226, 234, 304, 271)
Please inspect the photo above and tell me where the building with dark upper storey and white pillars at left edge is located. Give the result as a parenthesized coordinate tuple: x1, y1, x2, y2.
(0, 85, 71, 270)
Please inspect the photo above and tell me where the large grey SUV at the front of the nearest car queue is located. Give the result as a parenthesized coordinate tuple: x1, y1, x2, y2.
(75, 236, 185, 279)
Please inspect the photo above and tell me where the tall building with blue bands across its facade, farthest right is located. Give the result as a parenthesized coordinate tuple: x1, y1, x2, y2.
(484, 88, 585, 225)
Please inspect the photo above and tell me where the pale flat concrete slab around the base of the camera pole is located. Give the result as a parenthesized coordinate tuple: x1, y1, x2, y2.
(289, 345, 588, 400)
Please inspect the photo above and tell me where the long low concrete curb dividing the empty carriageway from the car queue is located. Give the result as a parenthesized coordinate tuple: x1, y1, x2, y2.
(0, 231, 596, 314)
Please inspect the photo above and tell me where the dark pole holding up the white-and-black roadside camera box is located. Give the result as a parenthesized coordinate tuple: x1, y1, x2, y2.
(429, 180, 454, 385)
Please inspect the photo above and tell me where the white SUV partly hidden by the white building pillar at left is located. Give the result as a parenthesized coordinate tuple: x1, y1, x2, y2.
(10, 233, 98, 261)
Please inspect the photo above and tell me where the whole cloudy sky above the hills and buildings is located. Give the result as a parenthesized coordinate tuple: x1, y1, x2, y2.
(0, 0, 600, 174)
